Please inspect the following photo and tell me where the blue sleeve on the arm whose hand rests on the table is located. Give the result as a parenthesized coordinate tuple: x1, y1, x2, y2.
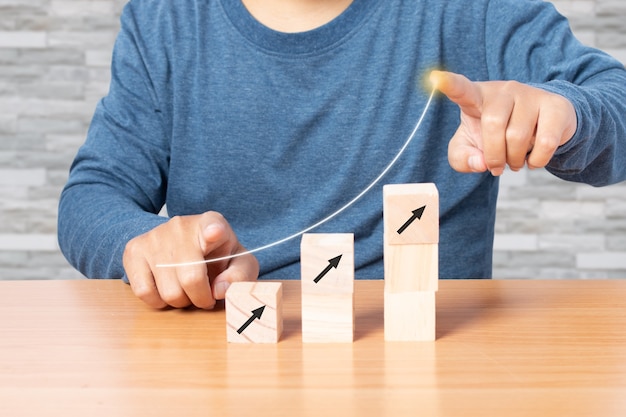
(58, 2, 169, 278)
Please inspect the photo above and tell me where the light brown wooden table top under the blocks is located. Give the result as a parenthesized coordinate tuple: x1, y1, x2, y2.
(0, 280, 626, 417)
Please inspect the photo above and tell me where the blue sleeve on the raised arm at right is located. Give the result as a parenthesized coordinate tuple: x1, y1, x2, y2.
(485, 0, 626, 186)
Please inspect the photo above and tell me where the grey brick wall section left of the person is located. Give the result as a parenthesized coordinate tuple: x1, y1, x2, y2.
(0, 0, 125, 279)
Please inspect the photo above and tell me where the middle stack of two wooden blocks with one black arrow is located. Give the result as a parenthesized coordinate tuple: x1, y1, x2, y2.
(300, 233, 354, 343)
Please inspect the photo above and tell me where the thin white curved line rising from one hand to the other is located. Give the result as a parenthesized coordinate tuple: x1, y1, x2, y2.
(156, 88, 436, 268)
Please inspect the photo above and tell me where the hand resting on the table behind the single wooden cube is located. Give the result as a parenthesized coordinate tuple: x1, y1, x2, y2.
(123, 212, 259, 309)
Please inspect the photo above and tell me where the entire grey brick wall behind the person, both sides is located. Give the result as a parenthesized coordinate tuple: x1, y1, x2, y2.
(0, 0, 626, 279)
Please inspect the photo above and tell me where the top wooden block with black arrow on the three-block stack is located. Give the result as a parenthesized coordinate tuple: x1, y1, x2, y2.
(383, 183, 439, 245)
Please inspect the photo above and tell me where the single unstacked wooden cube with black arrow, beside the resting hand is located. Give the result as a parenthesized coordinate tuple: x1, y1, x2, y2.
(225, 281, 283, 343)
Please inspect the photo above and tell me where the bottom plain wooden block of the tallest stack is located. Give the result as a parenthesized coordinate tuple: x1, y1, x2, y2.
(385, 291, 436, 341)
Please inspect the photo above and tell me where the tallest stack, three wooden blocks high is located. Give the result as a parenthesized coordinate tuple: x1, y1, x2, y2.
(383, 183, 439, 341)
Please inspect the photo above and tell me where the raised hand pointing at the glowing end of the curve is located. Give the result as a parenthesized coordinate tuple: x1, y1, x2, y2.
(430, 71, 577, 176)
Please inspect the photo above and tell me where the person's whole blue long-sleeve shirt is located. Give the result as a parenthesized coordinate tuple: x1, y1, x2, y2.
(58, 0, 626, 279)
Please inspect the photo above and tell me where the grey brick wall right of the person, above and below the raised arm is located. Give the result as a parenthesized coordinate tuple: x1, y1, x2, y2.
(494, 0, 626, 278)
